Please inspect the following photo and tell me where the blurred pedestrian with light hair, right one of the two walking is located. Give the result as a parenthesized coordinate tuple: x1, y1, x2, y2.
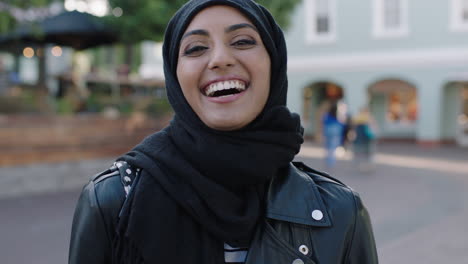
(353, 107, 376, 171)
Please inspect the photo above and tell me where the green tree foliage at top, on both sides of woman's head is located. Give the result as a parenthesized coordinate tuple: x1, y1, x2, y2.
(108, 0, 301, 43)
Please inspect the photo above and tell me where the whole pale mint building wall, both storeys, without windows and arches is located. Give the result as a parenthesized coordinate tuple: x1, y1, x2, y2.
(285, 0, 468, 141)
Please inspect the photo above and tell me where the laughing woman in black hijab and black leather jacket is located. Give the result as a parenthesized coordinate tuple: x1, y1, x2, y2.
(69, 0, 377, 264)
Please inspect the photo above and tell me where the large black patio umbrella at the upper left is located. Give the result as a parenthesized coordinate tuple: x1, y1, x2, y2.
(0, 11, 117, 50)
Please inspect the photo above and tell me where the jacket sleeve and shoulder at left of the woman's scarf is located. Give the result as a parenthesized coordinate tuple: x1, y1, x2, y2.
(68, 164, 125, 264)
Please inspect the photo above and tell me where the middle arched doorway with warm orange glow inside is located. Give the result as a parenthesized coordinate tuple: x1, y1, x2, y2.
(368, 79, 419, 139)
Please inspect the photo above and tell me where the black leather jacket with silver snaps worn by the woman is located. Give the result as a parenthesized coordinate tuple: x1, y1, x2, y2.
(69, 163, 378, 264)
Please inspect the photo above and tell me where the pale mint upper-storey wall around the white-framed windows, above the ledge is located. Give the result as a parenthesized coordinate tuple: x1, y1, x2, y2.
(286, 0, 468, 56)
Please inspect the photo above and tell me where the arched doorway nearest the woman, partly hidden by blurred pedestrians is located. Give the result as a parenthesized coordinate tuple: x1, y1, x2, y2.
(302, 81, 344, 140)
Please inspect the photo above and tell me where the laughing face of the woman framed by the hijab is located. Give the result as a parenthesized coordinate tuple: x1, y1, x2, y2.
(177, 6, 271, 130)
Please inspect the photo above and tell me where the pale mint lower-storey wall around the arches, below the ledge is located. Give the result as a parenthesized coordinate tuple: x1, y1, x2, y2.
(288, 66, 466, 140)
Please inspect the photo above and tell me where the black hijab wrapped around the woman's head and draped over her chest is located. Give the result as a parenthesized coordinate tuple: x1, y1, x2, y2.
(114, 0, 303, 264)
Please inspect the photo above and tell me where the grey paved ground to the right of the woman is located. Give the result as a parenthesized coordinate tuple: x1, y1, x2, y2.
(299, 144, 468, 264)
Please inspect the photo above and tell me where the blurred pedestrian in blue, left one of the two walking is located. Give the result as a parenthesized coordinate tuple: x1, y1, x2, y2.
(322, 103, 344, 168)
